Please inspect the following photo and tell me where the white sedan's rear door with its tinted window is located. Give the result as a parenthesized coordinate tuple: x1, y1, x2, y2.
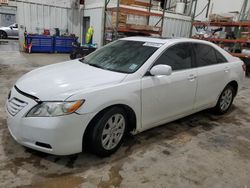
(193, 43, 230, 109)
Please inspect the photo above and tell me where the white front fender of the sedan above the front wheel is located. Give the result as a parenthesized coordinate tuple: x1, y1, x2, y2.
(67, 80, 141, 128)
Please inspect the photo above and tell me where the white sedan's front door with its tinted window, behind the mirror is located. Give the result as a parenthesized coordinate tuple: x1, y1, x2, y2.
(141, 43, 197, 129)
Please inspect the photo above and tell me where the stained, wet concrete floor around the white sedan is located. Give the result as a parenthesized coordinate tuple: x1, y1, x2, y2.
(0, 40, 250, 188)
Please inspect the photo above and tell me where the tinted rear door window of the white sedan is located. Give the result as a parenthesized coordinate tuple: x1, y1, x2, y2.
(194, 44, 217, 67)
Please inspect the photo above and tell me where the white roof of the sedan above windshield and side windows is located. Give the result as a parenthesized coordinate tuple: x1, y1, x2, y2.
(120, 37, 211, 44)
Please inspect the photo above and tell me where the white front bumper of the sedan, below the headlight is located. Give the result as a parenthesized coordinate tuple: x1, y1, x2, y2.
(6, 89, 94, 155)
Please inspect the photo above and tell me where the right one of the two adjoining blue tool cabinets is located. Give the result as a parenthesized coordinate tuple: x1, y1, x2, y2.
(54, 37, 77, 53)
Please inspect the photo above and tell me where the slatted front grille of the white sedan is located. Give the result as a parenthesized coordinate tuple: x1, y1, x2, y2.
(7, 97, 28, 116)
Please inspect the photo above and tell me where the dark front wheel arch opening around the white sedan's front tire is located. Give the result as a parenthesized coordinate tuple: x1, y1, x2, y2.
(82, 104, 137, 151)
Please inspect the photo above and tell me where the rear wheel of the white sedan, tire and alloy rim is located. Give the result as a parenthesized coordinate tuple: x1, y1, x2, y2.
(214, 85, 236, 115)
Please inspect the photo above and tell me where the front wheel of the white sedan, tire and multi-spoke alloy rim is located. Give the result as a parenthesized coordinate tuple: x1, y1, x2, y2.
(89, 107, 128, 157)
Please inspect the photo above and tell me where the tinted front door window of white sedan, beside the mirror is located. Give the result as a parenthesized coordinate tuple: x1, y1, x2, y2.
(155, 44, 192, 70)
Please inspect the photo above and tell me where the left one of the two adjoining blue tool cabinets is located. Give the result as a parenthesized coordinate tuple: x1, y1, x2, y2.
(26, 35, 54, 53)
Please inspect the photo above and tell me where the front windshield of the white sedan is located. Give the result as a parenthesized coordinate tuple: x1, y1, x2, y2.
(80, 40, 161, 73)
